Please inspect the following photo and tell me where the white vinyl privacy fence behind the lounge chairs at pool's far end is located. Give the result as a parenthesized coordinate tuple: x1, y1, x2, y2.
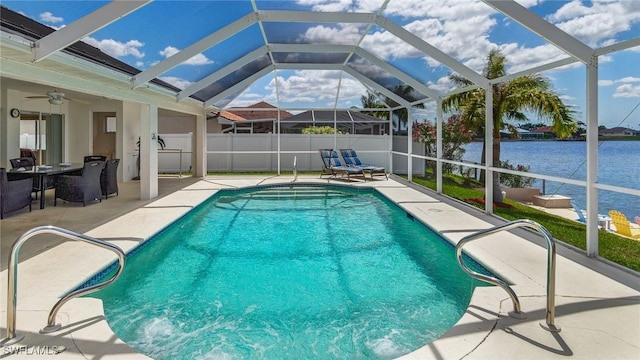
(158, 134, 424, 174)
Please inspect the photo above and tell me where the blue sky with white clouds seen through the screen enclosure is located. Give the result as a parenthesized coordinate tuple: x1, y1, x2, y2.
(3, 0, 640, 129)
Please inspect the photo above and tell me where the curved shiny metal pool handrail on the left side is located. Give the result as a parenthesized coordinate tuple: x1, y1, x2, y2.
(0, 226, 125, 346)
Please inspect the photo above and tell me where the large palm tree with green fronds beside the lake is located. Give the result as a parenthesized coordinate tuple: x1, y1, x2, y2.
(442, 49, 577, 202)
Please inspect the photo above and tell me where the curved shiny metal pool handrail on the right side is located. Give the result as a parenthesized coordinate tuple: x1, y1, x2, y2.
(456, 219, 560, 332)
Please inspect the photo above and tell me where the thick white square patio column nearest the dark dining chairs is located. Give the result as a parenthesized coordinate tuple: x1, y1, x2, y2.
(140, 104, 158, 200)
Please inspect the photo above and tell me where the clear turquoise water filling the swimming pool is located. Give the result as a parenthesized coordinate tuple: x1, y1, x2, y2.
(95, 186, 484, 359)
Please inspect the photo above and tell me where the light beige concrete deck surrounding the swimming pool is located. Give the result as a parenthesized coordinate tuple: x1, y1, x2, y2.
(0, 176, 640, 359)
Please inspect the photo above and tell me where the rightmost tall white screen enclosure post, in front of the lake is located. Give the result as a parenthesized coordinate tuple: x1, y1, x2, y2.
(585, 55, 598, 257)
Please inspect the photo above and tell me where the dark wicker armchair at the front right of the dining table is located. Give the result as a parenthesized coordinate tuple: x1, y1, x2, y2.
(53, 161, 105, 206)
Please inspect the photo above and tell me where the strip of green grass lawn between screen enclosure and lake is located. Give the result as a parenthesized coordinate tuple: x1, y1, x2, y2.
(413, 175, 640, 271)
